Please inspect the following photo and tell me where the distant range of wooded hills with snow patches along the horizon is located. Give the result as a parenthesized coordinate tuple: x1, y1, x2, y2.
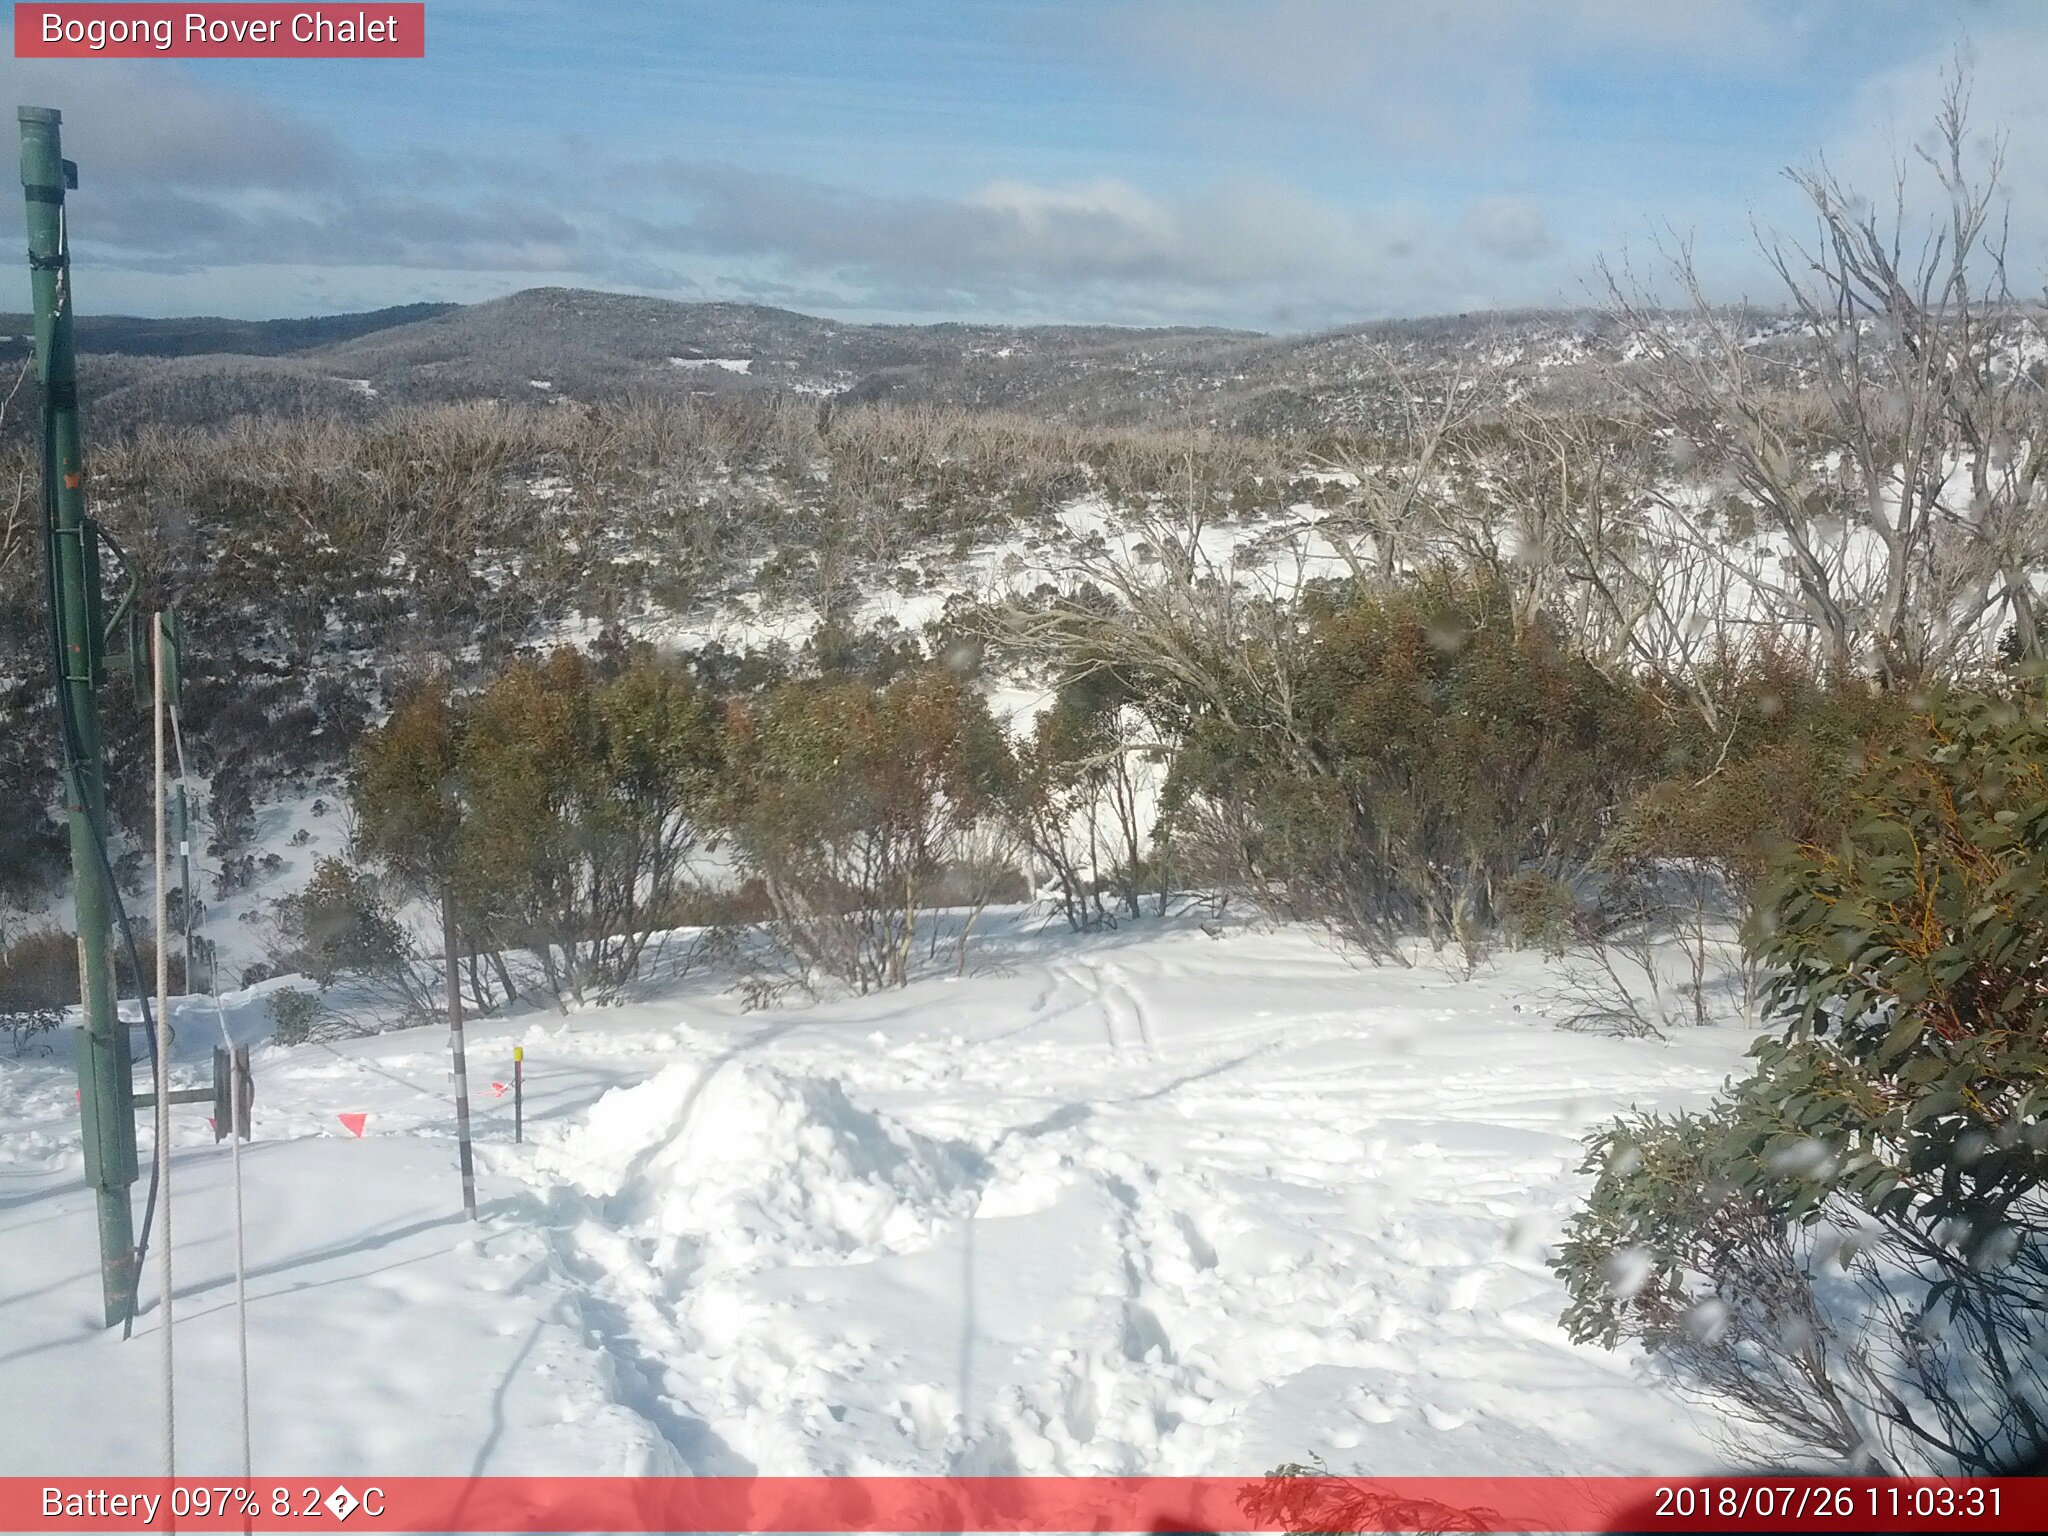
(0, 289, 1720, 434)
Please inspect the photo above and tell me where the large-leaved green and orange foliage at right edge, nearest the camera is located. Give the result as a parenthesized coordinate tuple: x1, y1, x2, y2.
(1755, 698, 2048, 1255)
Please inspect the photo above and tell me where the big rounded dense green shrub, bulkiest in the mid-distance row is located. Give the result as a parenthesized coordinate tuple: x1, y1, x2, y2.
(1169, 573, 1661, 958)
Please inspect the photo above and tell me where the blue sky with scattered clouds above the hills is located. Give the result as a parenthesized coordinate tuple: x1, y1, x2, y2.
(0, 0, 2048, 332)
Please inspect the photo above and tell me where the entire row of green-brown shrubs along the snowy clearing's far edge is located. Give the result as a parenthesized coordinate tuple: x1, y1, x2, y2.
(285, 569, 1923, 1032)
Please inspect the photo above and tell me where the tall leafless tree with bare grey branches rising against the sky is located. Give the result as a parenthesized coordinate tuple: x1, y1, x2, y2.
(1608, 78, 2048, 686)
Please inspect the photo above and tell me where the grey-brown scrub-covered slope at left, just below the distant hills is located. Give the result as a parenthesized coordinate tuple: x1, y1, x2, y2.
(0, 395, 1313, 921)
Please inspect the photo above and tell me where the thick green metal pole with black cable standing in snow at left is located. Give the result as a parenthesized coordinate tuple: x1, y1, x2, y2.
(20, 106, 139, 1327)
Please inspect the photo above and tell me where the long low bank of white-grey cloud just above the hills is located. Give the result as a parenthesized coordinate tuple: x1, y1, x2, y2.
(629, 162, 1569, 326)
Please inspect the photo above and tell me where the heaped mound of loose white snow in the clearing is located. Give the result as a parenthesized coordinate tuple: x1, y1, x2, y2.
(535, 1061, 981, 1270)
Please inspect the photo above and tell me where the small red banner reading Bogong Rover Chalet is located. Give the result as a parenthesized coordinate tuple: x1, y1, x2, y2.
(14, 0, 426, 59)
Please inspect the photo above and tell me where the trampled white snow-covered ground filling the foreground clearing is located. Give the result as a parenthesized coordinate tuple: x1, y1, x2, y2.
(0, 911, 1747, 1475)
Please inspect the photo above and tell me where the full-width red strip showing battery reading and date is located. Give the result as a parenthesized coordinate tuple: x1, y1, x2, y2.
(0, 1477, 2048, 1532)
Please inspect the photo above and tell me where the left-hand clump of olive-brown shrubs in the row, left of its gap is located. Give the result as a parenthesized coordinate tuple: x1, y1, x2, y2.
(276, 647, 1024, 1014)
